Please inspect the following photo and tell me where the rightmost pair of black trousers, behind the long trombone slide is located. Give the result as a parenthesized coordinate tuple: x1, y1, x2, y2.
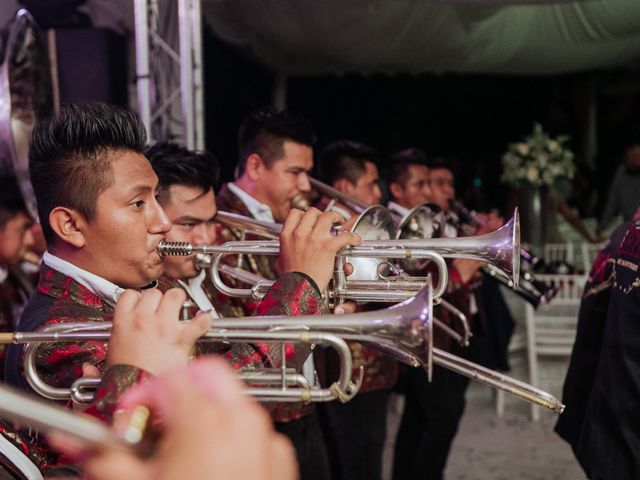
(393, 343, 475, 480)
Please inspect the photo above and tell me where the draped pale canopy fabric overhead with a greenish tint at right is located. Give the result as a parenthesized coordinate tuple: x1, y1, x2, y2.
(204, 0, 640, 75)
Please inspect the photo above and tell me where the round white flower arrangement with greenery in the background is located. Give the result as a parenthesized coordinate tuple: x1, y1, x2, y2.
(501, 123, 576, 187)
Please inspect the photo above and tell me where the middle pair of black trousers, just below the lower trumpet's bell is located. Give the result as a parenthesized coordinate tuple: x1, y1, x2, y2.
(327, 390, 391, 480)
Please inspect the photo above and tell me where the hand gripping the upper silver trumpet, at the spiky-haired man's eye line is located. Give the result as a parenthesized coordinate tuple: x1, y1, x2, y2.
(277, 208, 362, 291)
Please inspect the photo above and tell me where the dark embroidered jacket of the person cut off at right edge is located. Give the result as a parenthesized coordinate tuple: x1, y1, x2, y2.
(556, 222, 640, 480)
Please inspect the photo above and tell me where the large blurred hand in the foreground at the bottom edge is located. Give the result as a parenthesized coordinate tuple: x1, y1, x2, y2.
(76, 357, 298, 480)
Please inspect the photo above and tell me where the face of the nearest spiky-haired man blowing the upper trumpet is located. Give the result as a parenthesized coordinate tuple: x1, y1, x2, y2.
(83, 152, 171, 288)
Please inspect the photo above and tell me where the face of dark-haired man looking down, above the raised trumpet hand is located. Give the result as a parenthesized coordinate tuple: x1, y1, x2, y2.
(257, 140, 313, 222)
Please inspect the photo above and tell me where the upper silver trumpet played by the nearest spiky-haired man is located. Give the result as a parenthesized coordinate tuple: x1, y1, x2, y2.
(166, 210, 520, 303)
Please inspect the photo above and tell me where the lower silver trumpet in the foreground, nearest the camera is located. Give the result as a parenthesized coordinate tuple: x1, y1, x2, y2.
(0, 284, 433, 403)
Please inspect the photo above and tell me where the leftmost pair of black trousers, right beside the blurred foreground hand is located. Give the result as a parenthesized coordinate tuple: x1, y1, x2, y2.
(275, 412, 331, 480)
